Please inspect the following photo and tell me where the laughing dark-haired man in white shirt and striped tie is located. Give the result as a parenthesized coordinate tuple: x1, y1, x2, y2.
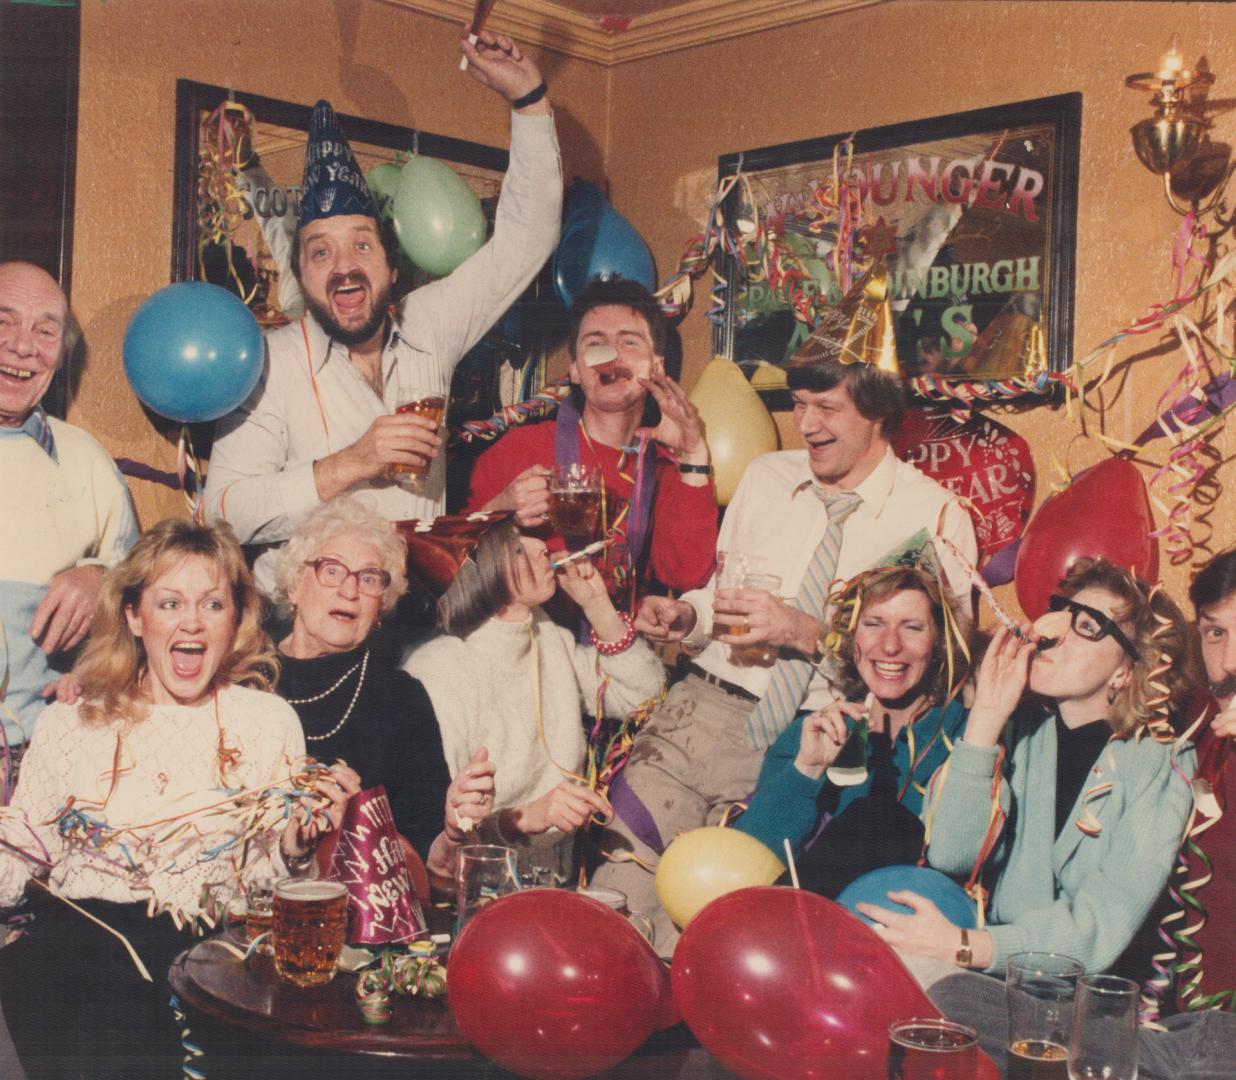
(595, 348, 976, 955)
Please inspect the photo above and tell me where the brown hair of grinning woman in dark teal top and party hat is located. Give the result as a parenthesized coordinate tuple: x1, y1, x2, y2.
(833, 566, 973, 703)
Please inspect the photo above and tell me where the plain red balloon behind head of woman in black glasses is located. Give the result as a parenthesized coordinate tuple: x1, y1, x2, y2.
(1015, 457, 1158, 619)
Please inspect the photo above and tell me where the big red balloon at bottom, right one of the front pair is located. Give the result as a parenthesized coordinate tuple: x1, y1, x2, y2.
(674, 886, 939, 1080)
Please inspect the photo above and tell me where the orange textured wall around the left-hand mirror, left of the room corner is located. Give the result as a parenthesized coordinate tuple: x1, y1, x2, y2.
(70, 0, 606, 525)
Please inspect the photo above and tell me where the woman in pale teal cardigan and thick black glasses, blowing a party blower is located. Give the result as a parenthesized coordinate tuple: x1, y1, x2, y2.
(859, 559, 1195, 975)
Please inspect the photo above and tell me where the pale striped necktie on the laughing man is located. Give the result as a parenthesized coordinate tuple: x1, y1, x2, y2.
(748, 484, 863, 749)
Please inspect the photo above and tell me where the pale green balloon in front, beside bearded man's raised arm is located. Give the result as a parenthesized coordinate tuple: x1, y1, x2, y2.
(393, 154, 486, 277)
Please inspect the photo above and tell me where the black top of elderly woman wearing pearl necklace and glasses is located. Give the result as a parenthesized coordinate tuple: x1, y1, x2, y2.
(278, 646, 451, 859)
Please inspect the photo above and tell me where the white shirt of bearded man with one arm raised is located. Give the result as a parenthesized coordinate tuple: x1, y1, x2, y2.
(205, 114, 562, 592)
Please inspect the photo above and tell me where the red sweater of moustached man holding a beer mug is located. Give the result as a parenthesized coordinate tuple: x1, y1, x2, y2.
(465, 420, 717, 610)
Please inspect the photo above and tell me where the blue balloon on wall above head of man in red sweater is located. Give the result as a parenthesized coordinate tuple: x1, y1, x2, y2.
(551, 180, 656, 308)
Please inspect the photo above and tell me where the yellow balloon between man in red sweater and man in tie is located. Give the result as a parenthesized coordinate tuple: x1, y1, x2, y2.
(690, 356, 777, 507)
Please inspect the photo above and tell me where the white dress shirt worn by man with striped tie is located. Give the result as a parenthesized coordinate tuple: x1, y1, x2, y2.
(682, 449, 978, 711)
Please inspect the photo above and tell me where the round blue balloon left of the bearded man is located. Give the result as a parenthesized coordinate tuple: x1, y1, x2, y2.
(125, 282, 265, 424)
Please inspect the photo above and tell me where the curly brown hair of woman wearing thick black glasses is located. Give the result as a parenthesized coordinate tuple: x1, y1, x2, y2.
(1059, 559, 1196, 739)
